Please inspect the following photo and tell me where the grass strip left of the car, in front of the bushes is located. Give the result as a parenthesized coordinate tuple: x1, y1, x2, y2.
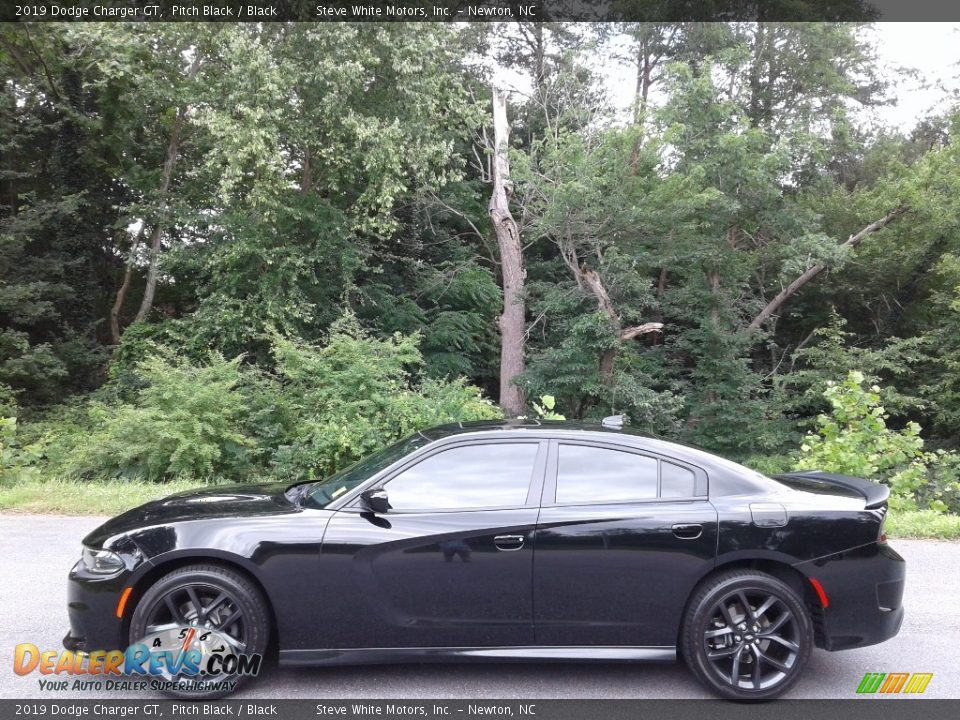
(0, 478, 209, 515)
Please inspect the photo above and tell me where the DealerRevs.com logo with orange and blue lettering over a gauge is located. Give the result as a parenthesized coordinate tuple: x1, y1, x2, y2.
(13, 625, 263, 694)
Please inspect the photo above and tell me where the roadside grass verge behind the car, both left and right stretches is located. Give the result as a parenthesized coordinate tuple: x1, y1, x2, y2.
(0, 479, 960, 540)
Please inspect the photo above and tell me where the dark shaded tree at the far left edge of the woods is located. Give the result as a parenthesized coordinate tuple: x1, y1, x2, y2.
(0, 25, 118, 407)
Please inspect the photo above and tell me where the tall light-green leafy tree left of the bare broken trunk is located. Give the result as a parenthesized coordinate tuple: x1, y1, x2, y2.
(115, 24, 480, 362)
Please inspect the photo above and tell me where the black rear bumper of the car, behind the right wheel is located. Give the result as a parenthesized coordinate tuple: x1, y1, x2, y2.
(796, 543, 906, 650)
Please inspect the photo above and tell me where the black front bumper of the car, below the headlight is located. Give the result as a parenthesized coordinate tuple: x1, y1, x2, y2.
(63, 563, 127, 653)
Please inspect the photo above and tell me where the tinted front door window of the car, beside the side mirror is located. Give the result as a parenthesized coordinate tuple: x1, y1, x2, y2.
(384, 443, 537, 510)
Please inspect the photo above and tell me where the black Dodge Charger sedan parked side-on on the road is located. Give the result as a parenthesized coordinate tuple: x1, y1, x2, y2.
(64, 421, 905, 700)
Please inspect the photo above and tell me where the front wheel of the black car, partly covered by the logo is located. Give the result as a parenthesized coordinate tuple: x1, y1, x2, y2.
(129, 564, 270, 700)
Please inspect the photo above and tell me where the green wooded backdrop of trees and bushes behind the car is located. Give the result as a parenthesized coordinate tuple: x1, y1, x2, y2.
(0, 22, 960, 528)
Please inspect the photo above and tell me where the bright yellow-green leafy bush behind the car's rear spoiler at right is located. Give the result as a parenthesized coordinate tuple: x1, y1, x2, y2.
(796, 370, 960, 512)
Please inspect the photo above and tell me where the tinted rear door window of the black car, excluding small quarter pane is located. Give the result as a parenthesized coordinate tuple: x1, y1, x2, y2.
(557, 445, 657, 503)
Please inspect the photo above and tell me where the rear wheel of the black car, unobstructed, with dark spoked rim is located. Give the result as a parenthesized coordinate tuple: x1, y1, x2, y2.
(680, 570, 813, 700)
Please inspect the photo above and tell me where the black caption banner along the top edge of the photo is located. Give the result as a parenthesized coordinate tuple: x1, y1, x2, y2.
(0, 0, 960, 22)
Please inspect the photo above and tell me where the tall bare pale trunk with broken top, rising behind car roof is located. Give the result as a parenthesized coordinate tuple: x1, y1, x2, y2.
(489, 89, 526, 415)
